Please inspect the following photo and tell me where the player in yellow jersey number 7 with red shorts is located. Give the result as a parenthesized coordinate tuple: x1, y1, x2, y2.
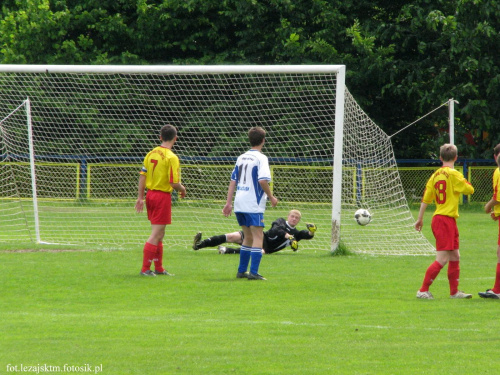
(135, 125, 186, 276)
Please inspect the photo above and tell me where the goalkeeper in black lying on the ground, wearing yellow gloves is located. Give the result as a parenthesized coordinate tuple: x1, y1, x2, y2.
(193, 210, 316, 254)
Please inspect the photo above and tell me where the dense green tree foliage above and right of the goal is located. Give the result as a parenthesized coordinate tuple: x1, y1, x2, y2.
(0, 0, 500, 158)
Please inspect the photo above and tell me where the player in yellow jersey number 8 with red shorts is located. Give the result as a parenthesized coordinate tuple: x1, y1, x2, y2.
(415, 144, 474, 299)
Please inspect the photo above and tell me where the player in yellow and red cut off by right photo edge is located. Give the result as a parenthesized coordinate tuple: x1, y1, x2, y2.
(478, 143, 500, 299)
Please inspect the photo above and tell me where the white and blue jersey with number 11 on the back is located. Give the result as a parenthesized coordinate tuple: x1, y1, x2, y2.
(231, 150, 271, 213)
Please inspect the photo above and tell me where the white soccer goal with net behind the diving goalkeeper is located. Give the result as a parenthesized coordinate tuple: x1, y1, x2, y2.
(0, 65, 433, 255)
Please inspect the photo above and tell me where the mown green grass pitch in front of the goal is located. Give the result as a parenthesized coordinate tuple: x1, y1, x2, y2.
(0, 208, 500, 375)
